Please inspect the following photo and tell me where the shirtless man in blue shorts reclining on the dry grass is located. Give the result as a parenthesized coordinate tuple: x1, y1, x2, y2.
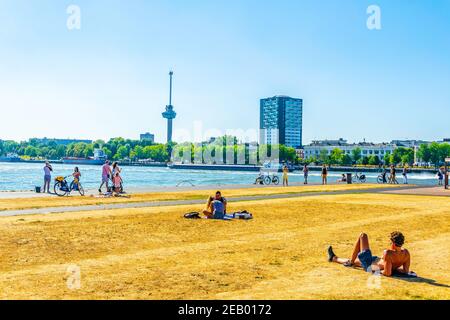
(328, 231, 411, 277)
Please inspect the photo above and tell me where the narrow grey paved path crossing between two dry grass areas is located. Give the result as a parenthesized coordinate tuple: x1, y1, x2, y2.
(0, 186, 440, 217)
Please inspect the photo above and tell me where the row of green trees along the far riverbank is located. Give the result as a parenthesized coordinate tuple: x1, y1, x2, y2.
(0, 136, 450, 166)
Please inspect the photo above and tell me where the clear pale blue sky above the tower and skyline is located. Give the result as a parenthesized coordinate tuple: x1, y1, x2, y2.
(0, 0, 450, 143)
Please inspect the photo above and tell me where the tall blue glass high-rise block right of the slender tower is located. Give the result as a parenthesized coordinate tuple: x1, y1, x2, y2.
(260, 96, 303, 148)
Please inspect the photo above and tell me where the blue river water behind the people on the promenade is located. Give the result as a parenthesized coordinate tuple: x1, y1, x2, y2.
(0, 163, 437, 191)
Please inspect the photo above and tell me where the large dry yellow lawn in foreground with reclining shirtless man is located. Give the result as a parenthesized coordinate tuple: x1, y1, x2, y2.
(0, 194, 450, 299)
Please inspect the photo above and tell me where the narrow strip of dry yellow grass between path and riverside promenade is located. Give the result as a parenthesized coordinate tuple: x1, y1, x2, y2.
(0, 184, 400, 211)
